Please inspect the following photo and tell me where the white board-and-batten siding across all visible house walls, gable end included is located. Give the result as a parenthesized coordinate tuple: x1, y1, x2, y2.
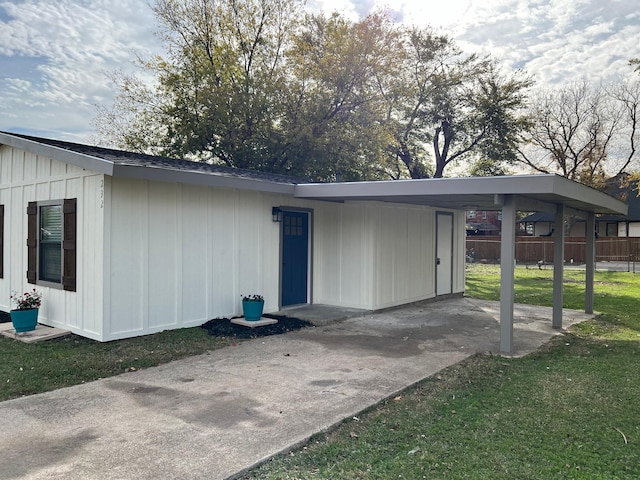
(0, 146, 464, 341)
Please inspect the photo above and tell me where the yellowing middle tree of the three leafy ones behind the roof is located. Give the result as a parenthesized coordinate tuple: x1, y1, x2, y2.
(285, 14, 402, 180)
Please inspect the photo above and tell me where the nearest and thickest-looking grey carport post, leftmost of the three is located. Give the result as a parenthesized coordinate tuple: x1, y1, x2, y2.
(500, 195, 516, 353)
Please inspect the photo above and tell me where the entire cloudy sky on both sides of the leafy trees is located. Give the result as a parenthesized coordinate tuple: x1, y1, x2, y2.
(0, 0, 640, 143)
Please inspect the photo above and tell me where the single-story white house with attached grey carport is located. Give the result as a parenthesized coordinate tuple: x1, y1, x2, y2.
(0, 132, 626, 352)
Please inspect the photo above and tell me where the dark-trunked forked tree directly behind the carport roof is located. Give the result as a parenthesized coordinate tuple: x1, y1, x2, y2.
(384, 29, 532, 178)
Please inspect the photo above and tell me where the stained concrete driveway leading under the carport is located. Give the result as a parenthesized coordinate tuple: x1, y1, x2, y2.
(0, 298, 591, 480)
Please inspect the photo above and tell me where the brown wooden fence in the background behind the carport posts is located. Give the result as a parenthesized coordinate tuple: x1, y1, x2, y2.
(467, 237, 640, 264)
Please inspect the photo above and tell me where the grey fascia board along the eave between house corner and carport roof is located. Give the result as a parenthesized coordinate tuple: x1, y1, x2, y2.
(113, 164, 295, 195)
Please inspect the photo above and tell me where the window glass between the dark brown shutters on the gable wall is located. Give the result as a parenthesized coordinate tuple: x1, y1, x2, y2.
(39, 205, 62, 283)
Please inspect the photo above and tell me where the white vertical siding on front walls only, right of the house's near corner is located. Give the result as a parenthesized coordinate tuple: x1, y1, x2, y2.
(105, 178, 464, 339)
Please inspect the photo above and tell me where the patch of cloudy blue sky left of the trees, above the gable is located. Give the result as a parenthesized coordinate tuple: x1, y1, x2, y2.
(0, 0, 158, 136)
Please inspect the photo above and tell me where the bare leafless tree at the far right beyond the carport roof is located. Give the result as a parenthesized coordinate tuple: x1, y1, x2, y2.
(519, 80, 640, 188)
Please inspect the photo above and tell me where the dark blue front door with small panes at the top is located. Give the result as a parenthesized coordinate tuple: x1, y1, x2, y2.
(282, 211, 309, 307)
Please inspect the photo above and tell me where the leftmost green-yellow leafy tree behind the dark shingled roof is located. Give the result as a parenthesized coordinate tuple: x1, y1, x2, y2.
(98, 0, 299, 171)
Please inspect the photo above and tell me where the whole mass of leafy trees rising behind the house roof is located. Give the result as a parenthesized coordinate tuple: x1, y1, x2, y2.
(95, 0, 531, 180)
